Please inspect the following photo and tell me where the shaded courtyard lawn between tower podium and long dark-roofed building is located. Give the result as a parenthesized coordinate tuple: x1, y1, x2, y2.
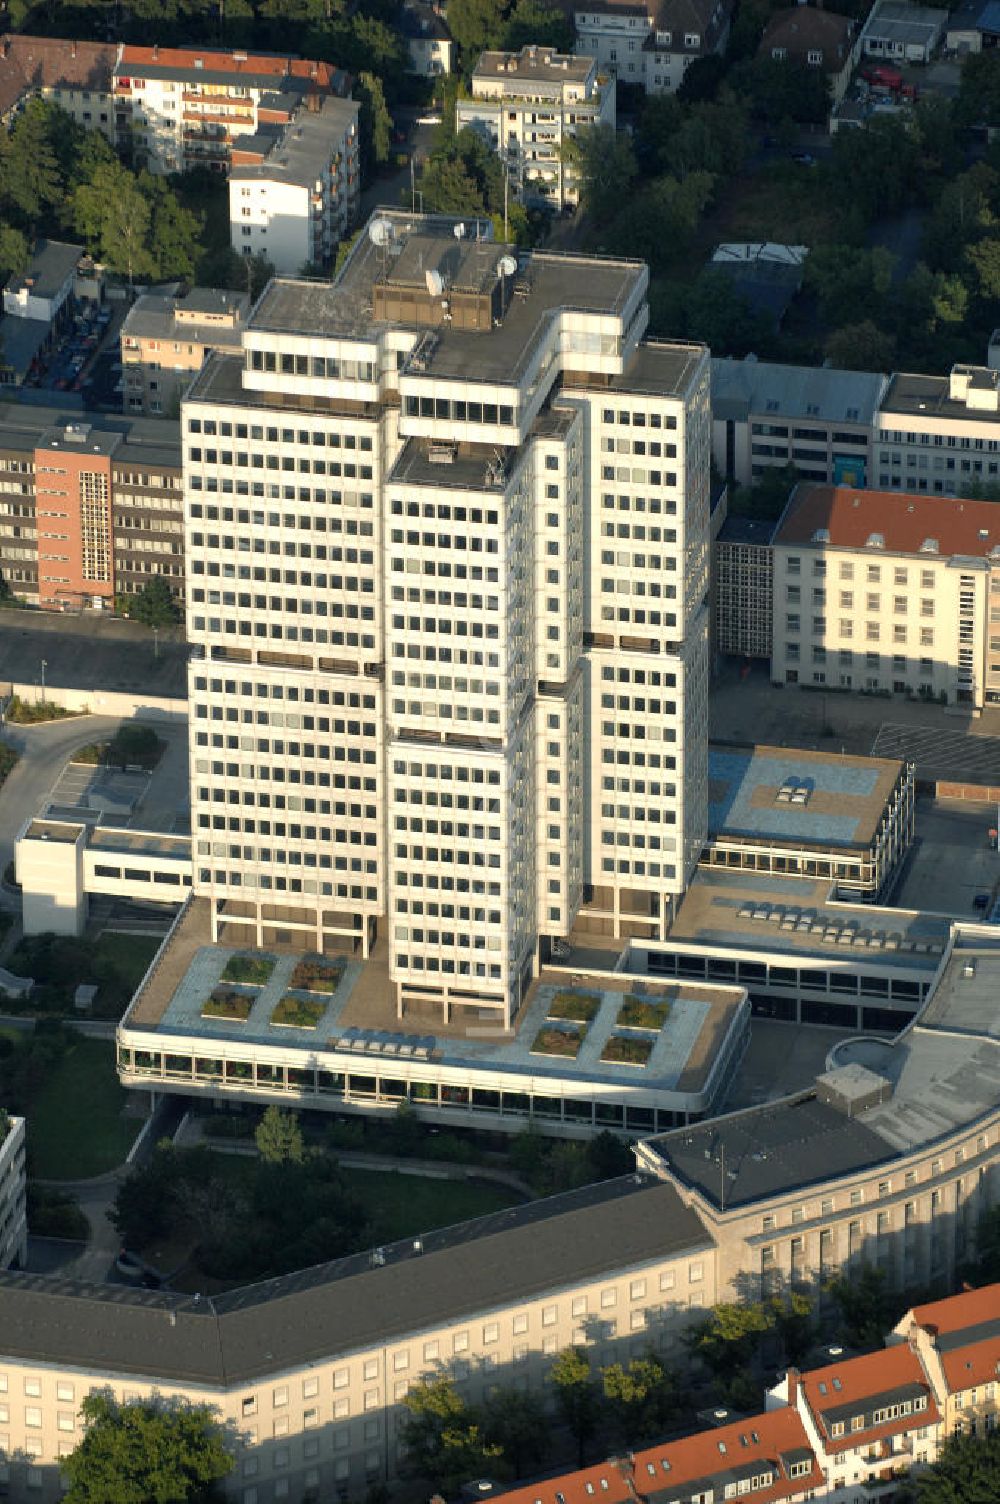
(343, 1170, 523, 1242)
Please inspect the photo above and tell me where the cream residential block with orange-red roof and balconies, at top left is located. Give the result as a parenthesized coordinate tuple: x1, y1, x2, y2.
(109, 44, 350, 173)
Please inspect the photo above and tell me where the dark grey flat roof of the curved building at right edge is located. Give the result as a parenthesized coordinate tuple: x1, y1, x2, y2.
(647, 925, 1000, 1208)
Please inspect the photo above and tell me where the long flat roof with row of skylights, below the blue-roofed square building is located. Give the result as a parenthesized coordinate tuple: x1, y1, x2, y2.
(668, 868, 950, 976)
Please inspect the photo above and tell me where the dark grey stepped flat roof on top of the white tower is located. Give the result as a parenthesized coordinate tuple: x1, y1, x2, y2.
(250, 209, 648, 384)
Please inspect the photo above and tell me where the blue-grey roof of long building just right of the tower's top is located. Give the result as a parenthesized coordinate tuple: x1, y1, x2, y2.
(711, 355, 886, 427)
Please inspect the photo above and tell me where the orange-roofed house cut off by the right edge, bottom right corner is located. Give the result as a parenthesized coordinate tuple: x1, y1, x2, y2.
(889, 1284, 1000, 1436)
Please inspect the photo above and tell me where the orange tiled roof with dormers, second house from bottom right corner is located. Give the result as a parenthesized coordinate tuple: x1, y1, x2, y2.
(798, 1343, 941, 1451)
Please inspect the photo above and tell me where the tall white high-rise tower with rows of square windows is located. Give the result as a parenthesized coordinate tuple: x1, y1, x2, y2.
(182, 214, 710, 1026)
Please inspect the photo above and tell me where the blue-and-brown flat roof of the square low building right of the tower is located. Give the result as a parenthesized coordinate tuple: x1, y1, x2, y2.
(708, 746, 902, 851)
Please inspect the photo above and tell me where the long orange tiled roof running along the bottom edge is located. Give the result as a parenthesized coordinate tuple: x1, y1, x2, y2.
(490, 1408, 823, 1504)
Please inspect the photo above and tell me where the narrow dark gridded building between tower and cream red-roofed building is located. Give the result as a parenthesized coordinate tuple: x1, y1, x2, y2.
(713, 516, 774, 659)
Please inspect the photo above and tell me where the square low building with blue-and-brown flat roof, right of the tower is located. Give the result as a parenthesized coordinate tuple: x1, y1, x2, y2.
(702, 746, 913, 901)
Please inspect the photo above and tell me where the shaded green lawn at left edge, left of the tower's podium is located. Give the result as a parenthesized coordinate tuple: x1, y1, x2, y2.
(26, 1036, 141, 1181)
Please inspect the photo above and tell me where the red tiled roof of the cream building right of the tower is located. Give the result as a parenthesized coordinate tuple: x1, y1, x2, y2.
(773, 484, 1000, 558)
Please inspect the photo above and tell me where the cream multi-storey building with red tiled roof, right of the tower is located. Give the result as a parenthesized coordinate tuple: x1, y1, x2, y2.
(771, 486, 1000, 708)
